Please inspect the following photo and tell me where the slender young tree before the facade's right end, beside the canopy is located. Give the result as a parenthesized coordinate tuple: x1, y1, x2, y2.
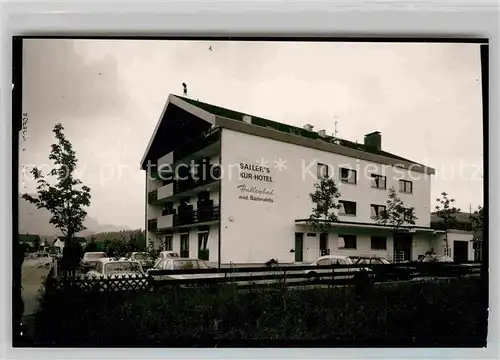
(376, 187, 418, 255)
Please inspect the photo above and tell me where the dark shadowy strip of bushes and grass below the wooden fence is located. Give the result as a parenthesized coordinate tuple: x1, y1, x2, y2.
(34, 278, 486, 346)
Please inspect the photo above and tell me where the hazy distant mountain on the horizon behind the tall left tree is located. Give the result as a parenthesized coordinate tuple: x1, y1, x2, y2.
(19, 196, 131, 237)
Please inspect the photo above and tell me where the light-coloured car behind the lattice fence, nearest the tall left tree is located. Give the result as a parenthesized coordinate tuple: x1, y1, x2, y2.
(86, 258, 144, 279)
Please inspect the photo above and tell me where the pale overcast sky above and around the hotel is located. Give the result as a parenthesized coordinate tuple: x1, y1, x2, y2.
(20, 39, 483, 228)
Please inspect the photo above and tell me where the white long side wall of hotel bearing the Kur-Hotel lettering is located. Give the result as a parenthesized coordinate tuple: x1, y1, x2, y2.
(221, 129, 430, 263)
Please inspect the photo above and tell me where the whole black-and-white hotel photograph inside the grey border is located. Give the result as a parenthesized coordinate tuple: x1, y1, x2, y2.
(12, 37, 489, 348)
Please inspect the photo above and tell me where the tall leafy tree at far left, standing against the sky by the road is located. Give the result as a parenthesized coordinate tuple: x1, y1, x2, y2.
(22, 124, 91, 273)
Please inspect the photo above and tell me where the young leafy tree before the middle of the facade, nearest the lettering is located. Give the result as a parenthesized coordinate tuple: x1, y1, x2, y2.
(307, 177, 340, 232)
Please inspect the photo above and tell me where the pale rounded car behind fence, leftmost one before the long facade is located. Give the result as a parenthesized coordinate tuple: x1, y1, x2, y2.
(305, 255, 372, 280)
